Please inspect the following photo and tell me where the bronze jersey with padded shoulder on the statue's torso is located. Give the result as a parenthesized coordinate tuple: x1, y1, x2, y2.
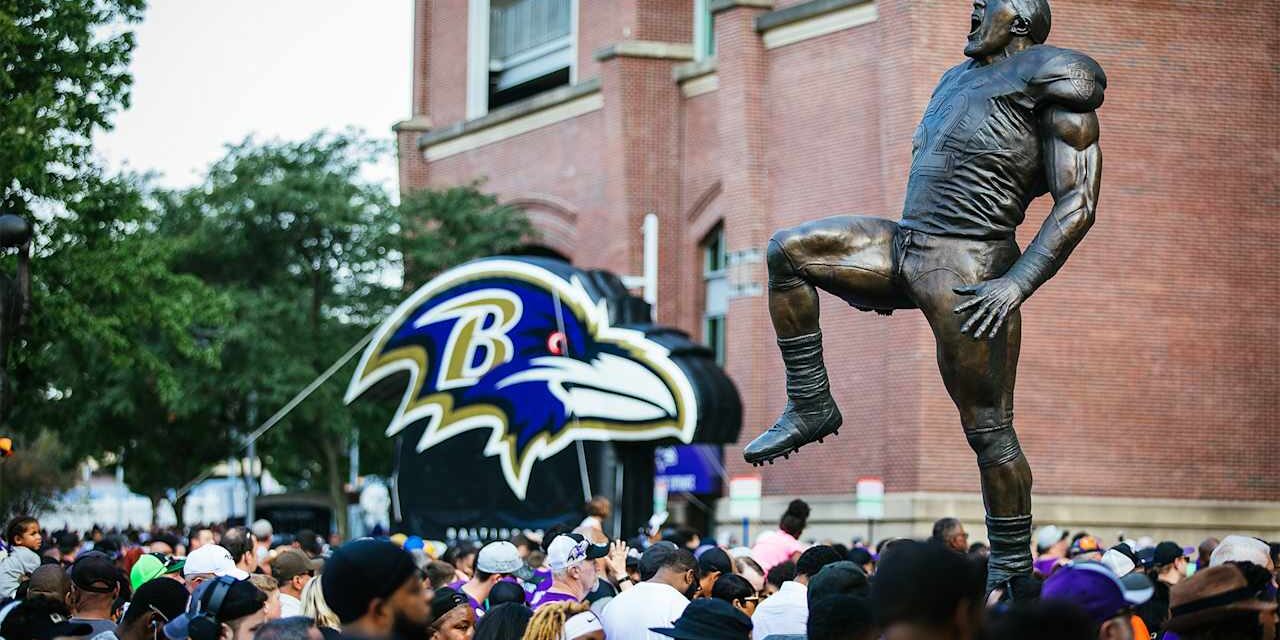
(900, 45, 1106, 238)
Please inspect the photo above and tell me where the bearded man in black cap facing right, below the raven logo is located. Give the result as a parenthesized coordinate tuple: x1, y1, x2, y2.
(319, 538, 439, 640)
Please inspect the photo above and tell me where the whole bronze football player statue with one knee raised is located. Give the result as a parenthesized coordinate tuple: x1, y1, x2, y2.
(745, 0, 1106, 590)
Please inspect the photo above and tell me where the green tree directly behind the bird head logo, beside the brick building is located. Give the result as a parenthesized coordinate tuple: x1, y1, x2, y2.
(164, 133, 530, 534)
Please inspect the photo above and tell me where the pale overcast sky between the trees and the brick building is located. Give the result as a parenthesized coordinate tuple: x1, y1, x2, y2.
(96, 0, 413, 188)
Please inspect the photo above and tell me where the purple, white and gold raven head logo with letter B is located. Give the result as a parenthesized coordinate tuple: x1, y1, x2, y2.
(346, 257, 698, 499)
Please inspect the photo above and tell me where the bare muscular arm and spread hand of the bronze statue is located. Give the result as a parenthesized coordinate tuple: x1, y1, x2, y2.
(955, 106, 1102, 338)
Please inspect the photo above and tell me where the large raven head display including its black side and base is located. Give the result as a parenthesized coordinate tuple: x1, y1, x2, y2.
(346, 257, 741, 537)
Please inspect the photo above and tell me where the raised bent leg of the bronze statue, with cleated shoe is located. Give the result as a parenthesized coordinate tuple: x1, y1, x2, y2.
(744, 216, 910, 465)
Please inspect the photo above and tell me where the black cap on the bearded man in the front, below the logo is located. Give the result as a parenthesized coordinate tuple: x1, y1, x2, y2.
(320, 538, 417, 625)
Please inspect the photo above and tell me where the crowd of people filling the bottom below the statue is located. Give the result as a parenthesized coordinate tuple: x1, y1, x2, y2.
(0, 500, 1280, 640)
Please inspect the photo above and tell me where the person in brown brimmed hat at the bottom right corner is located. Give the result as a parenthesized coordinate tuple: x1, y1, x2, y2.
(1165, 562, 1277, 640)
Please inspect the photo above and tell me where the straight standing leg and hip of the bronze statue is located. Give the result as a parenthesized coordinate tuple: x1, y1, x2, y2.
(905, 234, 1032, 590)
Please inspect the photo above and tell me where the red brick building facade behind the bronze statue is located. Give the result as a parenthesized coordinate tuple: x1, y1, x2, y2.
(396, 0, 1280, 541)
